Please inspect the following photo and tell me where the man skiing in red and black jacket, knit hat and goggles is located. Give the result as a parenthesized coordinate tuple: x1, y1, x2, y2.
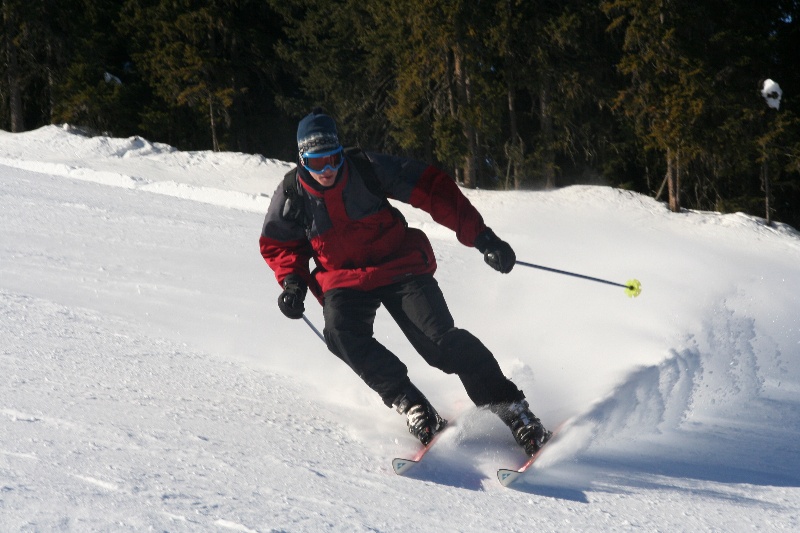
(259, 108, 551, 455)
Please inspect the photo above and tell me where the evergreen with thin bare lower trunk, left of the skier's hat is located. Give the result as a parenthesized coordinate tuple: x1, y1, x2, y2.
(119, 0, 278, 150)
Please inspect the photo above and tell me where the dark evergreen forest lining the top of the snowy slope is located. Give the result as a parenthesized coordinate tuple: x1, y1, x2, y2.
(0, 0, 800, 227)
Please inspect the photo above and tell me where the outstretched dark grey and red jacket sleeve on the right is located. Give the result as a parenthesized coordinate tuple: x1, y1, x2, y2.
(367, 153, 486, 246)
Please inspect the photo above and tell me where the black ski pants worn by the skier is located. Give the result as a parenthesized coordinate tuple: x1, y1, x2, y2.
(323, 275, 524, 406)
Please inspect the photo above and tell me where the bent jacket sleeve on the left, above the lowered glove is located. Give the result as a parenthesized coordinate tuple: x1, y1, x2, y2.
(259, 179, 313, 287)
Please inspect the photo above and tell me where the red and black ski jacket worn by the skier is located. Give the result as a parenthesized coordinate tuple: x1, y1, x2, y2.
(259, 153, 486, 301)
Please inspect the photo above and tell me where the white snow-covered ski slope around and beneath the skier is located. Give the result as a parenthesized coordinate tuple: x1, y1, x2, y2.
(0, 126, 800, 532)
